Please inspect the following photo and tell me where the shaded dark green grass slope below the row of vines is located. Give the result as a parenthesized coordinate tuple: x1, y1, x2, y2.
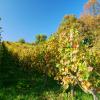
(0, 45, 100, 100)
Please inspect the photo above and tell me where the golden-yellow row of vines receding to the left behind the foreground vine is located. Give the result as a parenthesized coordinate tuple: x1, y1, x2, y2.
(4, 37, 57, 76)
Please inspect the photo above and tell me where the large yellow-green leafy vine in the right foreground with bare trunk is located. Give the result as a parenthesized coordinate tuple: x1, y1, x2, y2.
(56, 27, 96, 100)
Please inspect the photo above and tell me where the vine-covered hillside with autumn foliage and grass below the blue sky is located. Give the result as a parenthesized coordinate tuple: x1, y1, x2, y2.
(0, 11, 100, 100)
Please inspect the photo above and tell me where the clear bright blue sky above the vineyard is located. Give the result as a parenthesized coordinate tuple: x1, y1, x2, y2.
(0, 0, 87, 42)
